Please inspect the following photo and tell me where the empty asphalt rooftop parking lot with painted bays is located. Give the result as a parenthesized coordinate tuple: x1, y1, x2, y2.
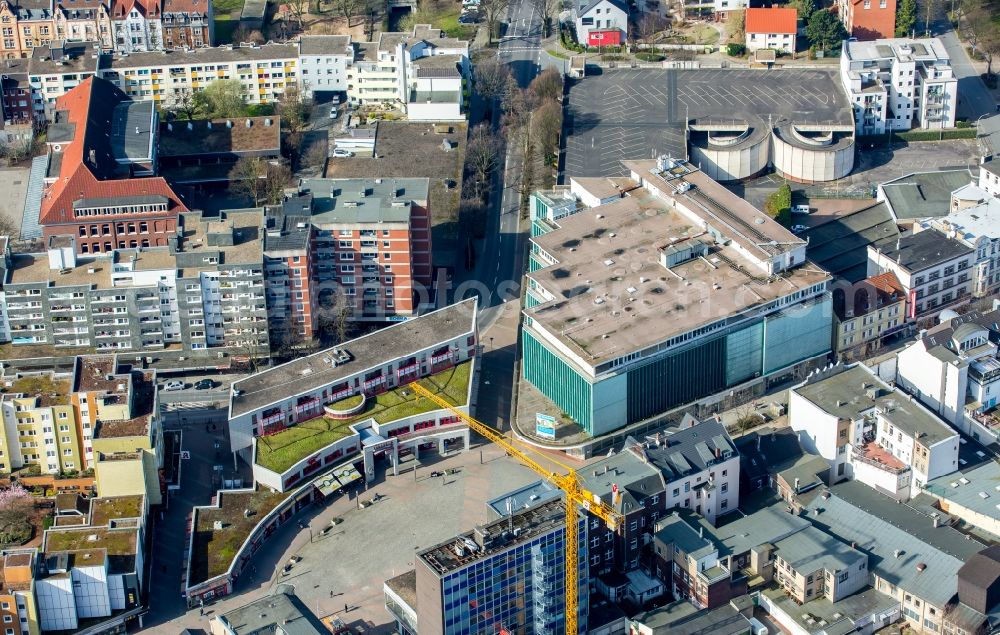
(563, 69, 852, 180)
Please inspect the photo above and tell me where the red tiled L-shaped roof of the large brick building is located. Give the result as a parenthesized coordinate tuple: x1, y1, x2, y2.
(39, 77, 187, 226)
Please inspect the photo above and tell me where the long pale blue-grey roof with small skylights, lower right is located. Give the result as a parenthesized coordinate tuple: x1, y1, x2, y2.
(807, 481, 983, 608)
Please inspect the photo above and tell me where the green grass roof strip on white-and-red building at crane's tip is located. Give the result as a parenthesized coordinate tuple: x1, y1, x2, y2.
(254, 362, 472, 474)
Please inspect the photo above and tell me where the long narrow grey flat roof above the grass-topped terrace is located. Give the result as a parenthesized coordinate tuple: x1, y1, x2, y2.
(230, 298, 476, 417)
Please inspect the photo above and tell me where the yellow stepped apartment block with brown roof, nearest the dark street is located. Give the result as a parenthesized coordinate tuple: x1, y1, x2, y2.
(73, 355, 163, 505)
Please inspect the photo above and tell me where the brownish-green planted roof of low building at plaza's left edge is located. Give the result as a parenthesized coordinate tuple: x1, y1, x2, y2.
(191, 491, 291, 584)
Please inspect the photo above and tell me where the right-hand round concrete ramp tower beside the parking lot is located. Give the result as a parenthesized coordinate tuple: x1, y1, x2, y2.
(771, 123, 854, 183)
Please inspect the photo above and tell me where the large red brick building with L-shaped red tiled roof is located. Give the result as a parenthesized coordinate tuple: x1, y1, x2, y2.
(39, 77, 187, 253)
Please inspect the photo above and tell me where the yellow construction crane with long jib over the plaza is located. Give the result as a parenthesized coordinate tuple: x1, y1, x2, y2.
(410, 382, 624, 635)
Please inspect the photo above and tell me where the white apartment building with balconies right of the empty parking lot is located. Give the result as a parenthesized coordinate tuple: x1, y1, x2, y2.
(840, 38, 958, 135)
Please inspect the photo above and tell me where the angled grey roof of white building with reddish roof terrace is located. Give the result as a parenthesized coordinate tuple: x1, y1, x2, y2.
(792, 363, 958, 446)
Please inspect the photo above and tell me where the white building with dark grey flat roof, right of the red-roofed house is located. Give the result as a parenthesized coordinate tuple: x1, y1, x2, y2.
(868, 231, 977, 322)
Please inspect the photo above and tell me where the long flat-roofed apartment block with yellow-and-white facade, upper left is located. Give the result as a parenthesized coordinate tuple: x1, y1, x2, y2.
(100, 42, 299, 105)
